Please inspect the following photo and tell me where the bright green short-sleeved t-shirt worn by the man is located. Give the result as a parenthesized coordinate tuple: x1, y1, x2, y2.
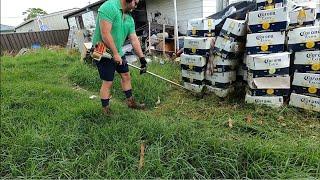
(92, 0, 135, 56)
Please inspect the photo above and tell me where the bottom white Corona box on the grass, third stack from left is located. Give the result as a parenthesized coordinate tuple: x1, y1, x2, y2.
(245, 94, 283, 108)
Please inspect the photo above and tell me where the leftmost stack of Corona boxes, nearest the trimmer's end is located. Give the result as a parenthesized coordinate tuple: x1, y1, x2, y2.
(180, 19, 215, 93)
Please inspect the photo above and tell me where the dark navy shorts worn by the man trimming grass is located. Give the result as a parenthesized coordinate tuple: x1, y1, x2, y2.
(94, 56, 129, 81)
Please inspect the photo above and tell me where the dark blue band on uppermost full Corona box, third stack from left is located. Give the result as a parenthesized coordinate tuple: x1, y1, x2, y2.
(249, 21, 288, 33)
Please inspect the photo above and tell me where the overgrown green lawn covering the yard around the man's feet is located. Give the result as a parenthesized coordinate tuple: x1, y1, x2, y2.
(0, 50, 320, 179)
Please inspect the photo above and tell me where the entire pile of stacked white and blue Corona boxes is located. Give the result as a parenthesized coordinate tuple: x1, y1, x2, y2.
(180, 0, 320, 112)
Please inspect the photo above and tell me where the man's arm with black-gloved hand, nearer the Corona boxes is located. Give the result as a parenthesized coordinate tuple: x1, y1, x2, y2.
(129, 33, 147, 74)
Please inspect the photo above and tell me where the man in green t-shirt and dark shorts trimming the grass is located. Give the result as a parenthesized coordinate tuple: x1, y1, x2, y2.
(92, 0, 147, 114)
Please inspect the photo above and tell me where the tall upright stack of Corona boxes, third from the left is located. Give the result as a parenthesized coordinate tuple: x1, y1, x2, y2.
(245, 1, 290, 107)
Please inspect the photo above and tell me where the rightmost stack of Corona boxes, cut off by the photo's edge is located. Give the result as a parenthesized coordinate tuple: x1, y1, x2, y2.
(288, 0, 320, 112)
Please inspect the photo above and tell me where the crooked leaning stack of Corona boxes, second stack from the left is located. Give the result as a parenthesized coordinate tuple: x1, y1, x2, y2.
(206, 18, 247, 97)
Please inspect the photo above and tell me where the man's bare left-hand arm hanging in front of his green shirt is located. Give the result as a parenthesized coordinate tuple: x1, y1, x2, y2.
(100, 20, 122, 65)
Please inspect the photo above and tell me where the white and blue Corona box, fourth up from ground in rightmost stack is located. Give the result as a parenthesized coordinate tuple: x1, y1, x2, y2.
(288, 26, 320, 52)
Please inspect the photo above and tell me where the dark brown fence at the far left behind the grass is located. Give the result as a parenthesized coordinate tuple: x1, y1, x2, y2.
(0, 29, 69, 52)
